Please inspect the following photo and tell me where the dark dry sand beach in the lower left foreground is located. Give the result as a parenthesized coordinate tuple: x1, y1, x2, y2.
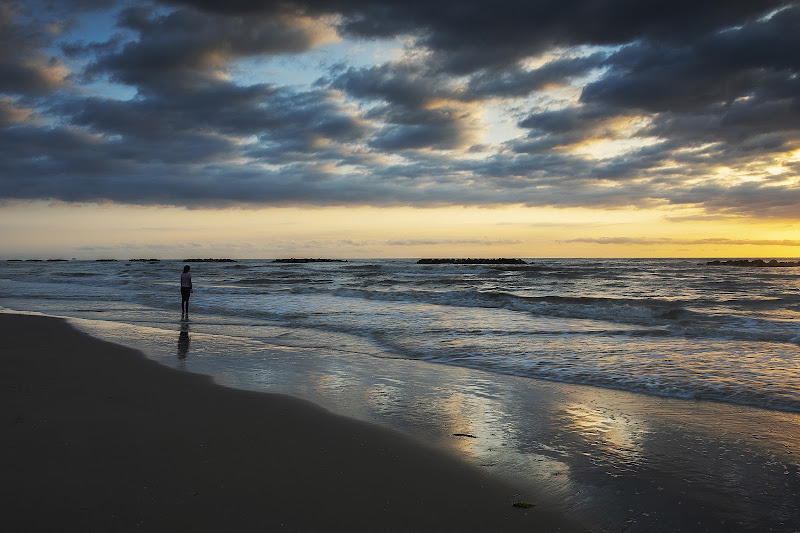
(0, 314, 584, 531)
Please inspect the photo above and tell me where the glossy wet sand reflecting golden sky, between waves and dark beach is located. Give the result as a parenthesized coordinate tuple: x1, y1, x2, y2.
(69, 323, 800, 532)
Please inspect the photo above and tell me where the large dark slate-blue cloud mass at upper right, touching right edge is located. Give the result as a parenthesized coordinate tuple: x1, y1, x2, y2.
(520, 7, 800, 142)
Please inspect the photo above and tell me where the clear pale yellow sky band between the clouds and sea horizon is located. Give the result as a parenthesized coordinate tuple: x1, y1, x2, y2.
(0, 202, 800, 259)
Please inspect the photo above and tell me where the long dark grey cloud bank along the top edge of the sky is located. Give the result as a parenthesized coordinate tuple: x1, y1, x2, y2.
(169, 0, 785, 73)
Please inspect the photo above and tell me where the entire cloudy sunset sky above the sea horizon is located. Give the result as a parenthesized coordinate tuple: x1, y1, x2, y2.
(0, 0, 800, 259)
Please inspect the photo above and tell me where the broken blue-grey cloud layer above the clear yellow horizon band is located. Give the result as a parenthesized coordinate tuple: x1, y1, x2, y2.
(0, 0, 800, 217)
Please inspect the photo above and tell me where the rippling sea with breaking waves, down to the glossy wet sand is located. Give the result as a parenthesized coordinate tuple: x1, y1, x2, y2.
(0, 259, 800, 412)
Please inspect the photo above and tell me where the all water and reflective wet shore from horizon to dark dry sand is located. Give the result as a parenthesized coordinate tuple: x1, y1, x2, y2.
(0, 258, 800, 531)
